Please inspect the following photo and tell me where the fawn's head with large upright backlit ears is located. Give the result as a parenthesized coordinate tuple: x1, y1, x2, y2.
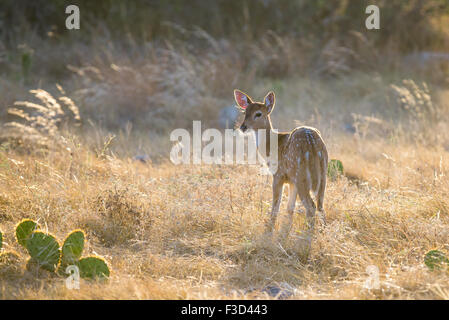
(234, 90, 275, 132)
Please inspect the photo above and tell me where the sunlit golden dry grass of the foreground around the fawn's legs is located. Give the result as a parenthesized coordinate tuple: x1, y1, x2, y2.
(0, 121, 449, 299)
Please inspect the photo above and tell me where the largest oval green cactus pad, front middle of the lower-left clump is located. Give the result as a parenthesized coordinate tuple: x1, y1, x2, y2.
(26, 231, 61, 272)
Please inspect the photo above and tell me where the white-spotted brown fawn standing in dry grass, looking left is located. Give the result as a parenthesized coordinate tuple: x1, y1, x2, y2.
(234, 90, 328, 240)
